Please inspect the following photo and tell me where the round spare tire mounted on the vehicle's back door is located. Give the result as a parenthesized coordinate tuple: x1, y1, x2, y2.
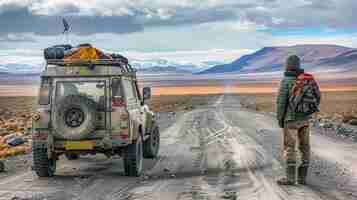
(52, 95, 97, 140)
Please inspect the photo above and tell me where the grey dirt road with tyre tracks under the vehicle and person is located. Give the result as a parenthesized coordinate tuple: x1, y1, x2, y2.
(0, 95, 357, 200)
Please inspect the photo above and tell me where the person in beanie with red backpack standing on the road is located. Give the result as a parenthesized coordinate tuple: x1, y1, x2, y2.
(277, 55, 321, 185)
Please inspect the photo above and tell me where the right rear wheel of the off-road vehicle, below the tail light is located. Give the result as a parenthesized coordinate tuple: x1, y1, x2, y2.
(123, 136, 143, 177)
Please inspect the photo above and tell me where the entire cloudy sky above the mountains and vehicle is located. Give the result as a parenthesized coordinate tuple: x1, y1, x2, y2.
(0, 0, 357, 71)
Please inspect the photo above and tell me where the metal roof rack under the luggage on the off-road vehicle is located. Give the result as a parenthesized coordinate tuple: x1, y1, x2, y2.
(45, 59, 136, 73)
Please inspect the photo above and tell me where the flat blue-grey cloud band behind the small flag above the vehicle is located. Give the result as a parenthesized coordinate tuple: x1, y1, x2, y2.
(0, 7, 143, 35)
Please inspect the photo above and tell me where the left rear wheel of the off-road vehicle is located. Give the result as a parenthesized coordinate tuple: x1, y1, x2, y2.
(32, 146, 56, 177)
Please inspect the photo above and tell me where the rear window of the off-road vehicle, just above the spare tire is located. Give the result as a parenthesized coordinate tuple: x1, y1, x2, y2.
(56, 81, 105, 105)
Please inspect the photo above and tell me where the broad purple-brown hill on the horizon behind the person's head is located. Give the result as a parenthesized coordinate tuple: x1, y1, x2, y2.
(198, 45, 357, 74)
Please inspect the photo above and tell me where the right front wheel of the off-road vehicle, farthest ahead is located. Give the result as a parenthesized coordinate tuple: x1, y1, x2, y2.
(144, 127, 160, 158)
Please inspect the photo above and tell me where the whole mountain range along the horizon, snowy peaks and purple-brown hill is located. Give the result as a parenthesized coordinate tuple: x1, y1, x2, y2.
(0, 45, 357, 75)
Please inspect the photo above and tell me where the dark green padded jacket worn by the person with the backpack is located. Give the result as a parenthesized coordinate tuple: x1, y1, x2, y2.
(276, 71, 309, 128)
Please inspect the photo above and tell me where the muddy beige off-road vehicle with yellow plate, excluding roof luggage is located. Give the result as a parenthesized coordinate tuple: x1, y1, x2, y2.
(32, 59, 160, 177)
